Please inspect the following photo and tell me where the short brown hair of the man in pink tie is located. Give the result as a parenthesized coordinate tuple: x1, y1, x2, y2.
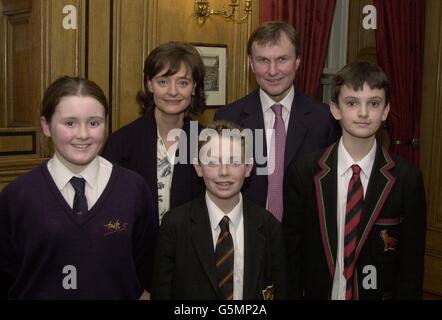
(247, 21, 302, 58)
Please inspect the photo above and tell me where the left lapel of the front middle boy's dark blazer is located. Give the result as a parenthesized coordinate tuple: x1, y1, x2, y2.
(191, 196, 218, 293)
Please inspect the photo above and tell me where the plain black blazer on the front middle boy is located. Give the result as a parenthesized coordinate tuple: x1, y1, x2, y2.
(152, 195, 286, 300)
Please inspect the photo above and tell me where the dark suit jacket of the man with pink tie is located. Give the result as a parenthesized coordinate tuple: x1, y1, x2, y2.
(215, 89, 340, 207)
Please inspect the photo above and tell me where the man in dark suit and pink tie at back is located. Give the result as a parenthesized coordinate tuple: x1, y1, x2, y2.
(215, 21, 339, 219)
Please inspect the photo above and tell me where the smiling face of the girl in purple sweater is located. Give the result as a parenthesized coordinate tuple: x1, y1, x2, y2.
(41, 96, 106, 168)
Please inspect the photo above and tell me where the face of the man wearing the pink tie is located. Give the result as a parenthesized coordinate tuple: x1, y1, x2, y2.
(249, 32, 300, 102)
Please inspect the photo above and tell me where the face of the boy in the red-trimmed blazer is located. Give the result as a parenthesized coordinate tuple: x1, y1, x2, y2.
(330, 83, 390, 140)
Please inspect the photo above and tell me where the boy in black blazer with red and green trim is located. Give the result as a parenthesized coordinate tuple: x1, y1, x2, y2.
(283, 62, 426, 300)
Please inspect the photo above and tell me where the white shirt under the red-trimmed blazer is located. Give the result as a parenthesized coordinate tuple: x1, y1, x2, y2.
(331, 138, 376, 300)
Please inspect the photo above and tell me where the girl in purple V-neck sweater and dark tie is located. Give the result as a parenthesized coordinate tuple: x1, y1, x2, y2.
(0, 76, 158, 299)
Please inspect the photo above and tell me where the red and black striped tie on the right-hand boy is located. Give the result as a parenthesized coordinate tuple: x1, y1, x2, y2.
(344, 165, 364, 300)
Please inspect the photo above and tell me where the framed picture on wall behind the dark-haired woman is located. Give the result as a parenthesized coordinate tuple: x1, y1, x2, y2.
(193, 43, 227, 108)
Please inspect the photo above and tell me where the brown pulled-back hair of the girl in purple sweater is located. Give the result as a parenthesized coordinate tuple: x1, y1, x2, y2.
(40, 76, 109, 122)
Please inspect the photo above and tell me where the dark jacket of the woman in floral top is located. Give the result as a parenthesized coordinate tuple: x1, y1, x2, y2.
(102, 110, 204, 218)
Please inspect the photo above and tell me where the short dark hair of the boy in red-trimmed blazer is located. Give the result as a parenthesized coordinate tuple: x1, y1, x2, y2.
(332, 61, 391, 105)
